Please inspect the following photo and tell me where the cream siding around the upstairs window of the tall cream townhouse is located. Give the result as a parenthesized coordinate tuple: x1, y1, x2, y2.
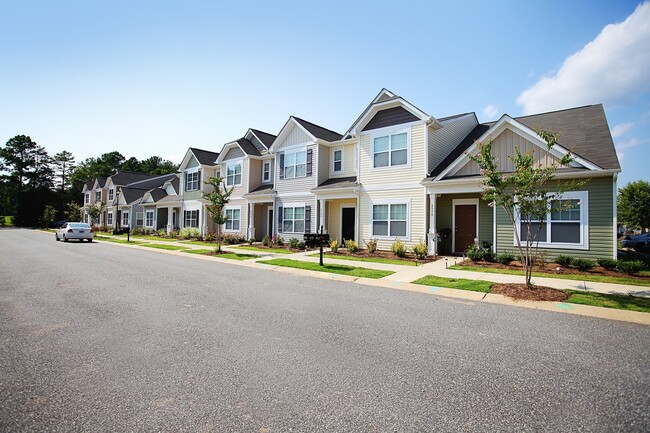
(360, 123, 426, 186)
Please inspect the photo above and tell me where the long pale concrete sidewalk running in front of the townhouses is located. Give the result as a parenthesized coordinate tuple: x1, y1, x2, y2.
(93, 235, 650, 298)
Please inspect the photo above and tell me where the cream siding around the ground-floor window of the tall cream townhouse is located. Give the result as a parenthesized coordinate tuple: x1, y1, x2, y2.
(357, 188, 426, 250)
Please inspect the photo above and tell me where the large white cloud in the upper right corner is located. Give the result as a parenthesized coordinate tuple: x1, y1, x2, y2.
(517, 2, 650, 114)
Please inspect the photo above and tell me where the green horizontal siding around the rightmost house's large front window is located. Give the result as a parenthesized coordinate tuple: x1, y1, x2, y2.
(497, 177, 616, 259)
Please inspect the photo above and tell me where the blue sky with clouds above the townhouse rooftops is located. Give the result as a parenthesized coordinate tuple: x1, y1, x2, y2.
(0, 0, 650, 185)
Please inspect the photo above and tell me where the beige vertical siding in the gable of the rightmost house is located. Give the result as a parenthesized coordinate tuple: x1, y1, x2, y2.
(451, 129, 558, 176)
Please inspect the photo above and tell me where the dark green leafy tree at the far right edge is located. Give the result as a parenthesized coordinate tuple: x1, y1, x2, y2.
(617, 180, 650, 233)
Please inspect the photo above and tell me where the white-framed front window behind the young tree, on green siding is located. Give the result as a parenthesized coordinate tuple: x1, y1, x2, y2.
(517, 191, 589, 248)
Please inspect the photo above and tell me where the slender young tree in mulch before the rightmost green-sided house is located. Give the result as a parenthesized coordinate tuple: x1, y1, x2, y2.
(469, 130, 584, 288)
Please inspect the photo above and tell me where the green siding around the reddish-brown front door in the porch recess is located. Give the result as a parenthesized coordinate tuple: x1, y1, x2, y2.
(434, 193, 494, 254)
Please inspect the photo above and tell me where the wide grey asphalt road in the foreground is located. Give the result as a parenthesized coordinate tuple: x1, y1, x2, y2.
(0, 230, 650, 432)
